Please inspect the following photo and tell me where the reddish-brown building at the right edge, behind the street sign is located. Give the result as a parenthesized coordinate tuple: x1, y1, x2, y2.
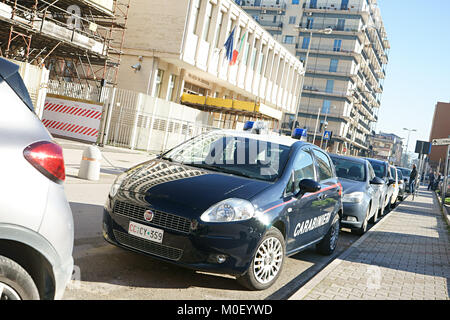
(429, 102, 450, 172)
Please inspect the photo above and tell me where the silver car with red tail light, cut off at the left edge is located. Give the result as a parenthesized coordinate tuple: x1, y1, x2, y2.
(0, 58, 74, 300)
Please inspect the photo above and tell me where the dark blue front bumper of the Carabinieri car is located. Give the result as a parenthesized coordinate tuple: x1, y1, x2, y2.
(103, 200, 265, 275)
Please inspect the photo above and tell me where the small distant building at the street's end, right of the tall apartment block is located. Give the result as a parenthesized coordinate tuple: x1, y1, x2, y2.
(369, 132, 403, 166)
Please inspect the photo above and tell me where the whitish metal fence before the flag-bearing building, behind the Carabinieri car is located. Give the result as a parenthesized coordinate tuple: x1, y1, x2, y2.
(104, 89, 220, 153)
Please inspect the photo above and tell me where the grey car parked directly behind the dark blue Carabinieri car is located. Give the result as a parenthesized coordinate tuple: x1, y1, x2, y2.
(330, 154, 384, 235)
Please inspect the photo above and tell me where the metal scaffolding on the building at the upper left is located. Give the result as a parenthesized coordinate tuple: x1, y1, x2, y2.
(0, 0, 131, 100)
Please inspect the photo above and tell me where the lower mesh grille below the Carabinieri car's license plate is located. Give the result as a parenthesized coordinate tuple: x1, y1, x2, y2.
(114, 230, 183, 261)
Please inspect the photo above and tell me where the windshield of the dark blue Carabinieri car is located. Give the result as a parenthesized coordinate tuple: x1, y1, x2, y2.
(161, 132, 291, 181)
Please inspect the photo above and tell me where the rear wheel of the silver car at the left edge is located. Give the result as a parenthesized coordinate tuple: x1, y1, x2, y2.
(0, 256, 39, 300)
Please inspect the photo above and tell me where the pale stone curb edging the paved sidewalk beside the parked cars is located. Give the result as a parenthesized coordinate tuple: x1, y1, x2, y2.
(288, 195, 406, 300)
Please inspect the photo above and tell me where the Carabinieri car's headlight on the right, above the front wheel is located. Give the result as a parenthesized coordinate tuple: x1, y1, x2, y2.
(200, 198, 255, 222)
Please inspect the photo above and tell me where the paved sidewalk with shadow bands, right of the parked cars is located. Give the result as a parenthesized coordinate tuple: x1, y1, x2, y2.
(290, 188, 450, 300)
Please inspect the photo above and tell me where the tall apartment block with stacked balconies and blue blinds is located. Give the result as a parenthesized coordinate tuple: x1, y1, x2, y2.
(236, 0, 390, 155)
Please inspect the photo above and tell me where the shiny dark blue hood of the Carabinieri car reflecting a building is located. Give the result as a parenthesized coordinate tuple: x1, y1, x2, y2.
(118, 160, 272, 218)
